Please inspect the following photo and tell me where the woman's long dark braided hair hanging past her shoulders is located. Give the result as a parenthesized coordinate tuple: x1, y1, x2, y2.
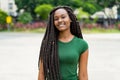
(38, 6, 83, 80)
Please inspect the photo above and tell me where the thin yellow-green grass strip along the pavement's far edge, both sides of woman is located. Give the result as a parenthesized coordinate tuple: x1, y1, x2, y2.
(0, 28, 120, 34)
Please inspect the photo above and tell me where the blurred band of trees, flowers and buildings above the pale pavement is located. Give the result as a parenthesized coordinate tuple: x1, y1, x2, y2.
(0, 0, 120, 32)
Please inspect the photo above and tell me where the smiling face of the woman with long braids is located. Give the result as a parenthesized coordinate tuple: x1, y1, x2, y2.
(54, 8, 71, 31)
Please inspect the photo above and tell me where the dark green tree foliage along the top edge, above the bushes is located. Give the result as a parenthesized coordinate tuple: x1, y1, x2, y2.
(15, 0, 120, 20)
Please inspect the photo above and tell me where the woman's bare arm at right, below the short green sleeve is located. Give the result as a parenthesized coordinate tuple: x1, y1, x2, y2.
(79, 49, 88, 80)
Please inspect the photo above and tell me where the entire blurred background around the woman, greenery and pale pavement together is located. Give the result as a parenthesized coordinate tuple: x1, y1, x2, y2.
(0, 0, 120, 80)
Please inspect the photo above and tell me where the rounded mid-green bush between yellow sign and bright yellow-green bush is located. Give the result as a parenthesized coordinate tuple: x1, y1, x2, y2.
(18, 12, 33, 24)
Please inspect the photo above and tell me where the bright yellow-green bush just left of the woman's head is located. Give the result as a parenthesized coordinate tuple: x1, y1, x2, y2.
(35, 4, 53, 20)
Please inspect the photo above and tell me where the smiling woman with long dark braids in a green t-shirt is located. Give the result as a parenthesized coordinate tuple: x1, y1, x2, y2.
(38, 6, 88, 80)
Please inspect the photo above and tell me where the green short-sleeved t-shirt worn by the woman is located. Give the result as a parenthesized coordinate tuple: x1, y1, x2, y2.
(58, 36, 88, 80)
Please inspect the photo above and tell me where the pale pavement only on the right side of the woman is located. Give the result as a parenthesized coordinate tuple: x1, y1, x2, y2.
(86, 34, 120, 80)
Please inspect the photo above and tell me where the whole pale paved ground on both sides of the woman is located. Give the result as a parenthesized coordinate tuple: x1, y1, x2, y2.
(0, 32, 120, 80)
